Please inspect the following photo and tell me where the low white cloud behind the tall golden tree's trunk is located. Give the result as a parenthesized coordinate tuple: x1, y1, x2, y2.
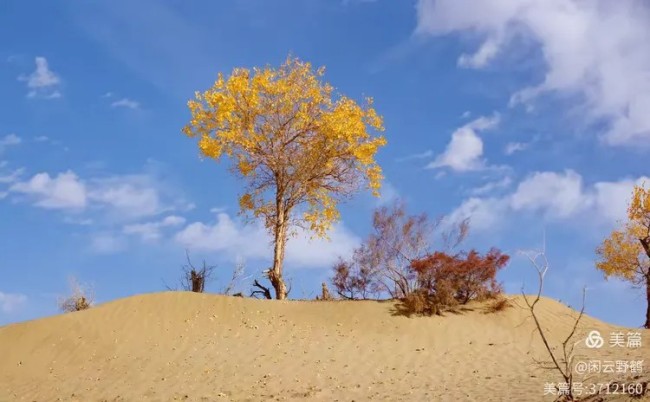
(175, 213, 360, 268)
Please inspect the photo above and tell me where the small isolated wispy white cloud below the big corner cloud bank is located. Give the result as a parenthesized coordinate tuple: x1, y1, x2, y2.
(427, 115, 499, 172)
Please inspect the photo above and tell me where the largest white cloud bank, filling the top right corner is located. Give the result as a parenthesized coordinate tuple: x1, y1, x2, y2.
(416, 0, 650, 145)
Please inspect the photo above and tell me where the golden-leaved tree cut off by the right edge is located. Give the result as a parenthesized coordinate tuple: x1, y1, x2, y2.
(596, 186, 650, 328)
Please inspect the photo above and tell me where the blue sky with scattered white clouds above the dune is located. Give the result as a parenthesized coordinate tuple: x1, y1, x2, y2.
(0, 0, 650, 326)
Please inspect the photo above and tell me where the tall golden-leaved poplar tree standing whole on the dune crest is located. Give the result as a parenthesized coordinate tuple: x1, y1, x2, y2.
(183, 57, 386, 299)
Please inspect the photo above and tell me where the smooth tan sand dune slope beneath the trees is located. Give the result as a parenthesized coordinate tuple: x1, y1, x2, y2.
(0, 292, 650, 401)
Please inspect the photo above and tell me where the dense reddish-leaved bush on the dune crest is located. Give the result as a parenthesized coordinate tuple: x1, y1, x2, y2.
(410, 248, 510, 313)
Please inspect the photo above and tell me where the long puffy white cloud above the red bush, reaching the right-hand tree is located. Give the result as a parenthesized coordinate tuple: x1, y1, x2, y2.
(448, 170, 650, 230)
